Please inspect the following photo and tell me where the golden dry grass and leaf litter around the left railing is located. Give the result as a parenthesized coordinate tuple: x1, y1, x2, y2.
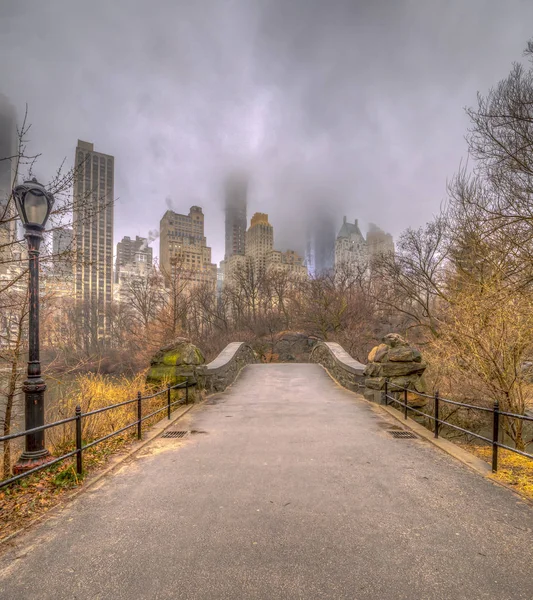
(0, 373, 185, 540)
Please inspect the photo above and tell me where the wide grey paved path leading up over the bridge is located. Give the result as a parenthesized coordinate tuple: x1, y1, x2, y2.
(0, 365, 533, 600)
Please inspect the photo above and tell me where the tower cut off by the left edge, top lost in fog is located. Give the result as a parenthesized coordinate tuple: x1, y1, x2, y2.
(0, 94, 18, 275)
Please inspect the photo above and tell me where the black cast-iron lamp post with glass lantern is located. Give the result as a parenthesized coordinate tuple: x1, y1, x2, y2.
(13, 178, 54, 473)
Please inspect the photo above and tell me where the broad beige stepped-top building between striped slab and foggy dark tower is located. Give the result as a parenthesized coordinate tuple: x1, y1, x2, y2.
(159, 206, 217, 291)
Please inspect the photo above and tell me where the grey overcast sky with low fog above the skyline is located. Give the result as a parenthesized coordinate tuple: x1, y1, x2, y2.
(0, 0, 533, 262)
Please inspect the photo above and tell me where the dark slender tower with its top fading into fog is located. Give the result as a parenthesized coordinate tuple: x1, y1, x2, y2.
(224, 173, 248, 260)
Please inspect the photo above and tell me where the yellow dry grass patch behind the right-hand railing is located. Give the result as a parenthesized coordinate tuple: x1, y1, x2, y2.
(456, 442, 533, 500)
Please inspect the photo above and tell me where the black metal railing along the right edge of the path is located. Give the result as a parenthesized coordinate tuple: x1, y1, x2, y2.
(385, 381, 533, 473)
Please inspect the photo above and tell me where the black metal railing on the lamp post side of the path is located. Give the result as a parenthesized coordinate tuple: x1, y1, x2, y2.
(0, 380, 198, 488)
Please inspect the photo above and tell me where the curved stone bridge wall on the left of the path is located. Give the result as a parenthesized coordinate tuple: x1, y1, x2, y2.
(197, 342, 258, 394)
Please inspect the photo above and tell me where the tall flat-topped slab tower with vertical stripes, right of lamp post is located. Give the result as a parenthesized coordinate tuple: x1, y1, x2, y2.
(73, 140, 115, 347)
